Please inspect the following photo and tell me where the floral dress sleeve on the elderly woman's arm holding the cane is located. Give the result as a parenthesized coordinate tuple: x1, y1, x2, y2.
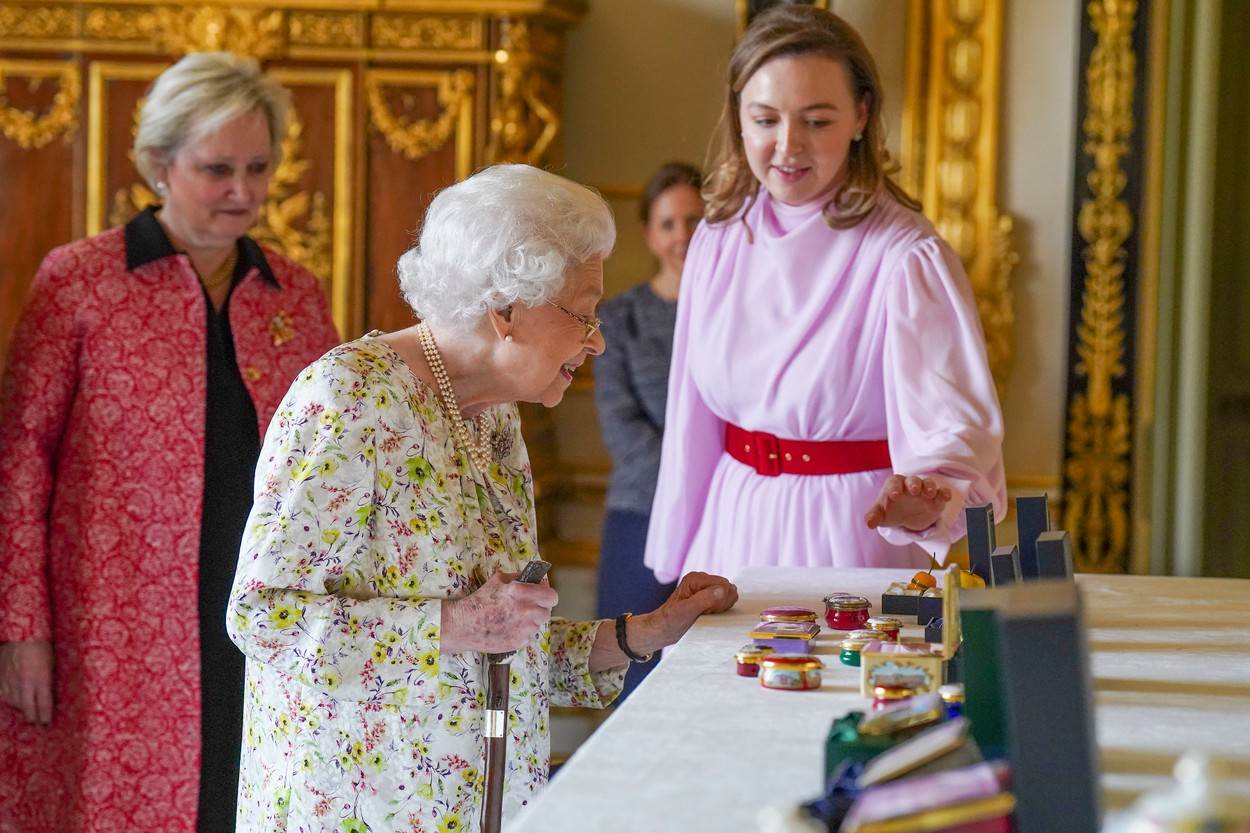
(226, 354, 443, 704)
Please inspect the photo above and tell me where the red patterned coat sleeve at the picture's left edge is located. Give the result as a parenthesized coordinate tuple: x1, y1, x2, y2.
(0, 249, 83, 642)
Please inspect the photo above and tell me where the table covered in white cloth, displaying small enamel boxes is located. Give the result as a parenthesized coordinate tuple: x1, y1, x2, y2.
(509, 568, 1250, 833)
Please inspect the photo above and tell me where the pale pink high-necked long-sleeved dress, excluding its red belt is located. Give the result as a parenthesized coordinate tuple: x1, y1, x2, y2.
(646, 193, 1006, 582)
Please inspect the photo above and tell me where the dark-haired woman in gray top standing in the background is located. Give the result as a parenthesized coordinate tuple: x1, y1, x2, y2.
(595, 163, 704, 698)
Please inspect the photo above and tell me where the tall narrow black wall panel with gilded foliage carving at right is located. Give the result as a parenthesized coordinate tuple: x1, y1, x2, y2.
(1063, 0, 1146, 572)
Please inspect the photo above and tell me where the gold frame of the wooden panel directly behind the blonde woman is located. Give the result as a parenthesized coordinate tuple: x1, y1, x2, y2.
(85, 61, 363, 335)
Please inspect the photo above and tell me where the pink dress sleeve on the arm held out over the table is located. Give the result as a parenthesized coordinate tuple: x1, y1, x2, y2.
(880, 238, 1006, 560)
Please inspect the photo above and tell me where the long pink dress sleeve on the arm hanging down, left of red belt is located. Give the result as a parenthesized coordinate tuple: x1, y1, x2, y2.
(644, 223, 725, 583)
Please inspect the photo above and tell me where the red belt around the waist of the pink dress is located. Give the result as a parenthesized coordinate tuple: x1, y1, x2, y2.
(725, 425, 894, 478)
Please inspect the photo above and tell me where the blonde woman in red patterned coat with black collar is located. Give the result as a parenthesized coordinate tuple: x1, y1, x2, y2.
(0, 53, 339, 833)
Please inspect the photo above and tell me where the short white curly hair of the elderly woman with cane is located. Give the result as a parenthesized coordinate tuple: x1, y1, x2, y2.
(399, 165, 616, 328)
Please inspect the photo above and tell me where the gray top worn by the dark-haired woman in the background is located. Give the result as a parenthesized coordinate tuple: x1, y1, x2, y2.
(595, 283, 678, 514)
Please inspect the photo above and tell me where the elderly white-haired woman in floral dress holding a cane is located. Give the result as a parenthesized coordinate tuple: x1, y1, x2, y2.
(228, 165, 738, 833)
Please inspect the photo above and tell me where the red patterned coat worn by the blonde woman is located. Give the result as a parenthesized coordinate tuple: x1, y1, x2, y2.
(0, 215, 339, 833)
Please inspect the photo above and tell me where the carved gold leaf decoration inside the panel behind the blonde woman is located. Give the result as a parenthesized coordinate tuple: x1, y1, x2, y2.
(109, 103, 333, 279)
